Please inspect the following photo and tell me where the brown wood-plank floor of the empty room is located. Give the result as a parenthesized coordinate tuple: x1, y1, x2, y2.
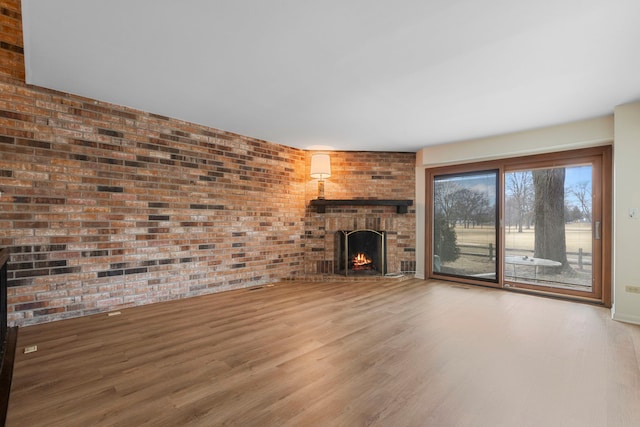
(7, 279, 640, 427)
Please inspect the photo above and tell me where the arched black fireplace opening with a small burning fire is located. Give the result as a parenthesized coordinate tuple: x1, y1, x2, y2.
(334, 230, 387, 276)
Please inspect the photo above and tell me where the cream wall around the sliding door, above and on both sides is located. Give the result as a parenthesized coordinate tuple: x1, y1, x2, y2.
(416, 113, 640, 323)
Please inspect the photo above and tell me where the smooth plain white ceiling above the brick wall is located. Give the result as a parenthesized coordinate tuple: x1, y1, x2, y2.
(22, 0, 640, 151)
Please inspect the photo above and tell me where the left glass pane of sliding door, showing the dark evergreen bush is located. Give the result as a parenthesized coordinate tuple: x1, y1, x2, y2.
(433, 171, 498, 282)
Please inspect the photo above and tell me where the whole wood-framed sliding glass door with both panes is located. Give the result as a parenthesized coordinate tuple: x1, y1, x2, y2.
(427, 147, 611, 305)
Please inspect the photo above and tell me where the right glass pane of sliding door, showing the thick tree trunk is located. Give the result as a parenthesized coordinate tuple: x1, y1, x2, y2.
(504, 165, 592, 292)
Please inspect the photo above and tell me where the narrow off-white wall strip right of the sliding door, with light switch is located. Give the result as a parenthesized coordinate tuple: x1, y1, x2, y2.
(612, 102, 640, 324)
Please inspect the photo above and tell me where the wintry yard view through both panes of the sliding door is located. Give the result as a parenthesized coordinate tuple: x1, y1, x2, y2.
(433, 165, 592, 292)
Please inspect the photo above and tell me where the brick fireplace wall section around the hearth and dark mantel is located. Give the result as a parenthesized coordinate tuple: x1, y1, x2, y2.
(305, 152, 416, 274)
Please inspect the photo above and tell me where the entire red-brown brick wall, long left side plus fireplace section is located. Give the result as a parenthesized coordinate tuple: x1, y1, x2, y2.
(0, 0, 415, 326)
